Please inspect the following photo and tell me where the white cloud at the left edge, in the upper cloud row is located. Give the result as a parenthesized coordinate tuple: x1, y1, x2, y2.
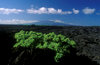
(0, 8, 23, 14)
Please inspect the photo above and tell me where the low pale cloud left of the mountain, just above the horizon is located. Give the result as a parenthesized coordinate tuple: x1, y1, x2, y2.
(0, 19, 39, 24)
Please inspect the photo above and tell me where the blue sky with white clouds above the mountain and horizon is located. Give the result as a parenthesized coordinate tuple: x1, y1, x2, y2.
(0, 0, 100, 26)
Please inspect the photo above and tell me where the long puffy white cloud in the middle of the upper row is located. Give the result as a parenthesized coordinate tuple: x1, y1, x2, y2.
(27, 7, 72, 14)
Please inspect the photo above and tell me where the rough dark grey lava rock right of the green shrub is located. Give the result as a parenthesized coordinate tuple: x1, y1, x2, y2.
(61, 27, 100, 64)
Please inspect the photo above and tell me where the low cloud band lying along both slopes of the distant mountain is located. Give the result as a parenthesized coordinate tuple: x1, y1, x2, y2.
(0, 19, 72, 25)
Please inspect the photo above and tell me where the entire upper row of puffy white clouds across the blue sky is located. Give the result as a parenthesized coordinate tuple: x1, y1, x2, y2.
(0, 7, 96, 15)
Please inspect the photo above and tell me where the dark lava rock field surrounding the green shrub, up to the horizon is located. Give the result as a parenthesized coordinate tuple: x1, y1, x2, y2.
(0, 25, 100, 65)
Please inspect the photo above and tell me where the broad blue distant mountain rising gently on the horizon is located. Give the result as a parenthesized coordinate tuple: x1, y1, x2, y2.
(0, 20, 76, 26)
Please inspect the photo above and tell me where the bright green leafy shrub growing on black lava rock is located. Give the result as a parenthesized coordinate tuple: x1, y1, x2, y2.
(13, 31, 76, 62)
